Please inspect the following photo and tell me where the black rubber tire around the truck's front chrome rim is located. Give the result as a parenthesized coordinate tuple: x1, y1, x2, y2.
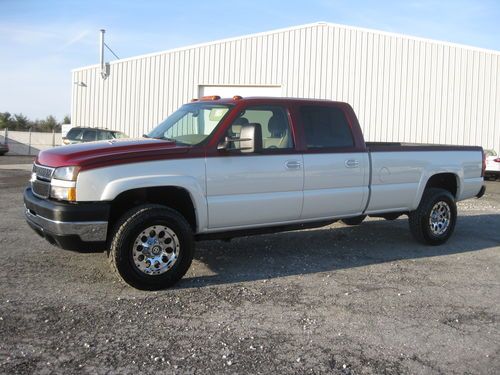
(108, 204, 194, 290)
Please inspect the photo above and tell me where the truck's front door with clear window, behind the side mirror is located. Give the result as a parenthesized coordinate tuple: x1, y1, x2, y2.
(206, 106, 304, 229)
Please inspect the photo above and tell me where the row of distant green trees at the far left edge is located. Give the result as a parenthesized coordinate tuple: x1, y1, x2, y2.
(0, 112, 71, 133)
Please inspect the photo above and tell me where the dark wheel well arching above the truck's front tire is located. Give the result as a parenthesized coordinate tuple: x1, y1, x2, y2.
(109, 186, 196, 232)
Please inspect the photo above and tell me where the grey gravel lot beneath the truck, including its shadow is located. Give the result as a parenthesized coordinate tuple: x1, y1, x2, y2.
(0, 169, 500, 374)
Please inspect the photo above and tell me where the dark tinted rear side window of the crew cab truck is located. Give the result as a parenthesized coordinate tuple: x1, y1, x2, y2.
(300, 106, 354, 149)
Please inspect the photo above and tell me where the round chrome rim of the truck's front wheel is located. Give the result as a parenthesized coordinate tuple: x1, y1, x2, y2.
(132, 225, 180, 275)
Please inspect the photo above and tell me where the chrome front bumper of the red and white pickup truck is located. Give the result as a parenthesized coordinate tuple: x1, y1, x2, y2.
(24, 206, 108, 242)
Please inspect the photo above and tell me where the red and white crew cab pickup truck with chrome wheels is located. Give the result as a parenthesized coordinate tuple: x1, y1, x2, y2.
(24, 96, 485, 290)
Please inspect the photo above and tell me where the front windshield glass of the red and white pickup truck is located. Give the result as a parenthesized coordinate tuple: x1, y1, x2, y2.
(147, 102, 232, 145)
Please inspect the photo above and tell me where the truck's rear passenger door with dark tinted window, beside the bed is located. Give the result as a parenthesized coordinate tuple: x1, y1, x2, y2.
(298, 105, 370, 219)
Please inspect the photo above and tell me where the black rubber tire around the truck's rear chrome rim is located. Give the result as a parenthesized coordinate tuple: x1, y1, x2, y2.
(408, 188, 457, 246)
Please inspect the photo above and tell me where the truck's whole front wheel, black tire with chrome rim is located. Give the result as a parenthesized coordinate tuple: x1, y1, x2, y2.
(109, 205, 194, 290)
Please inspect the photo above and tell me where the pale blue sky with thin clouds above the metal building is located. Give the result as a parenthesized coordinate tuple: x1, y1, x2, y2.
(0, 0, 500, 120)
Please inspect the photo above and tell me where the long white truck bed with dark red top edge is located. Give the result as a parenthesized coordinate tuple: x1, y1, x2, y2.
(366, 142, 483, 214)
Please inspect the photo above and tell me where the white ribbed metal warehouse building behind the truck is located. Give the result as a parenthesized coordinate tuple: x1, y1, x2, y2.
(71, 23, 500, 151)
